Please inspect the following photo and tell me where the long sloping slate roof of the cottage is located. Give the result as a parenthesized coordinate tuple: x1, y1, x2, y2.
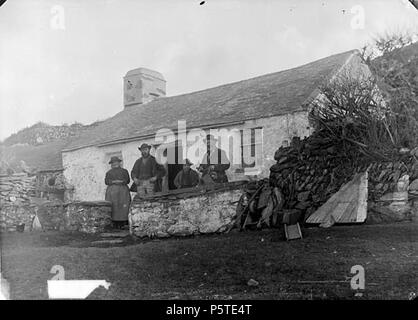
(63, 50, 357, 151)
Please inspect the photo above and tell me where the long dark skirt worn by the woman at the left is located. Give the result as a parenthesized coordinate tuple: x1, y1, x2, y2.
(106, 184, 131, 221)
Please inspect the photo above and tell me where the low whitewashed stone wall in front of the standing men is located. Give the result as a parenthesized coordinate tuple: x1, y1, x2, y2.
(129, 182, 245, 237)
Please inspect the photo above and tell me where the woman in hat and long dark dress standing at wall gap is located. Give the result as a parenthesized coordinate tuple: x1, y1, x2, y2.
(105, 157, 131, 228)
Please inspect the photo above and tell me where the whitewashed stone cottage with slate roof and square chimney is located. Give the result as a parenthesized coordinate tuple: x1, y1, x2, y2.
(62, 51, 370, 200)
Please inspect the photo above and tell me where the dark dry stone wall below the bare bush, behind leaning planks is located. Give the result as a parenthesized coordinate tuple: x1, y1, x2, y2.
(270, 131, 418, 219)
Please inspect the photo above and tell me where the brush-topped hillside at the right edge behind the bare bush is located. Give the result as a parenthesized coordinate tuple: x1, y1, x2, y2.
(362, 32, 418, 148)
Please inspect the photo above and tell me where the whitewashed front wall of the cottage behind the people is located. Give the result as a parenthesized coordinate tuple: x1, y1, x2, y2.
(63, 112, 311, 201)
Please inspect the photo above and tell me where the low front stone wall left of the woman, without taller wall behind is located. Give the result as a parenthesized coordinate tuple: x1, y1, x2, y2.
(0, 201, 112, 233)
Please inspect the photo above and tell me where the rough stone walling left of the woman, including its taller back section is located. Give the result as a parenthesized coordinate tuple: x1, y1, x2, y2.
(0, 171, 104, 233)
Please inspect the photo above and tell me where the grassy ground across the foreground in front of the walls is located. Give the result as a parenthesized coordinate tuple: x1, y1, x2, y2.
(1, 223, 418, 299)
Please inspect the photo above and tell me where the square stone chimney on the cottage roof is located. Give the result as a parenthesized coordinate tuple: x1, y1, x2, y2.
(123, 68, 165, 108)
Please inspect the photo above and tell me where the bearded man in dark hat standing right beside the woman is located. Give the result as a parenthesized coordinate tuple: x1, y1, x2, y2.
(131, 143, 158, 197)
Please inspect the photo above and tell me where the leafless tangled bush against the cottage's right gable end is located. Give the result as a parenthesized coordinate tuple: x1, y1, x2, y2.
(310, 73, 399, 160)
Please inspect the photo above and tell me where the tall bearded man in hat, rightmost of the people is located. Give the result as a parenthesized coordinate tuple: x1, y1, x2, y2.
(198, 134, 230, 183)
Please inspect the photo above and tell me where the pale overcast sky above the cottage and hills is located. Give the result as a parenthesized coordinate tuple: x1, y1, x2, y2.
(0, 0, 418, 139)
